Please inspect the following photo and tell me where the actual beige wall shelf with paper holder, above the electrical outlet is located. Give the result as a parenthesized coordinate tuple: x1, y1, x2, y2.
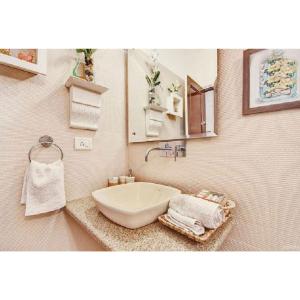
(65, 76, 108, 130)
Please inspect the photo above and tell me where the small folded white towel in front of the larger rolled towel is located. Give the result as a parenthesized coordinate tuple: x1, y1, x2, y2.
(167, 208, 205, 235)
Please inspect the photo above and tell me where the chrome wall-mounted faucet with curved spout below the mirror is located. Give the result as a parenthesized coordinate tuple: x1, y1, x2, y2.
(145, 141, 186, 162)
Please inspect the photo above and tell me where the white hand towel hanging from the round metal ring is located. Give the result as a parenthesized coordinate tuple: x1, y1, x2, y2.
(21, 160, 66, 216)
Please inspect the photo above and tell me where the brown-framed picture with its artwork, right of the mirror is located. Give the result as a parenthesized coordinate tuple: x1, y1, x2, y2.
(243, 49, 300, 115)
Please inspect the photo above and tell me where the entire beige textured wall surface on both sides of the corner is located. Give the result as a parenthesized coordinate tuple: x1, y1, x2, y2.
(0, 50, 300, 250)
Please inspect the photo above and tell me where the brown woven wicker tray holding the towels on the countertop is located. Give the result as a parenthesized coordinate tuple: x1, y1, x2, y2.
(158, 212, 232, 243)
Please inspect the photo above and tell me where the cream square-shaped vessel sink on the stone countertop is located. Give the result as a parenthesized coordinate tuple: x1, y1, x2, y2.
(92, 182, 181, 229)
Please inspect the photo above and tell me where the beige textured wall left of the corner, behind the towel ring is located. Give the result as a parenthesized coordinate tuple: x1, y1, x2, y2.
(0, 50, 128, 250)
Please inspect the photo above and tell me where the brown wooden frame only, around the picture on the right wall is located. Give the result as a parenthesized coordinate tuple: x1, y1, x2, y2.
(242, 49, 300, 115)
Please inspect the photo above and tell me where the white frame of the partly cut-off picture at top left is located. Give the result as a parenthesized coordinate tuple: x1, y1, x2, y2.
(0, 49, 47, 75)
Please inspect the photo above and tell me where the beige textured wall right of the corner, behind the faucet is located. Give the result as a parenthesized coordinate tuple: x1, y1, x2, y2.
(129, 50, 300, 250)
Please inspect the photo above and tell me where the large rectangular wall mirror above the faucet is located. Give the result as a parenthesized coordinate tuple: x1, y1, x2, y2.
(127, 49, 217, 143)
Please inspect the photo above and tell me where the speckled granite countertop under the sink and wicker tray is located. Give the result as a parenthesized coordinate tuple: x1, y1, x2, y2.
(66, 197, 233, 251)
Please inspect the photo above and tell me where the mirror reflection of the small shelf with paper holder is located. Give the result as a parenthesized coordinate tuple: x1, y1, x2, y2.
(144, 104, 167, 136)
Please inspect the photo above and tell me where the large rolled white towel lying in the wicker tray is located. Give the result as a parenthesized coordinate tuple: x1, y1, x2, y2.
(169, 194, 225, 229)
